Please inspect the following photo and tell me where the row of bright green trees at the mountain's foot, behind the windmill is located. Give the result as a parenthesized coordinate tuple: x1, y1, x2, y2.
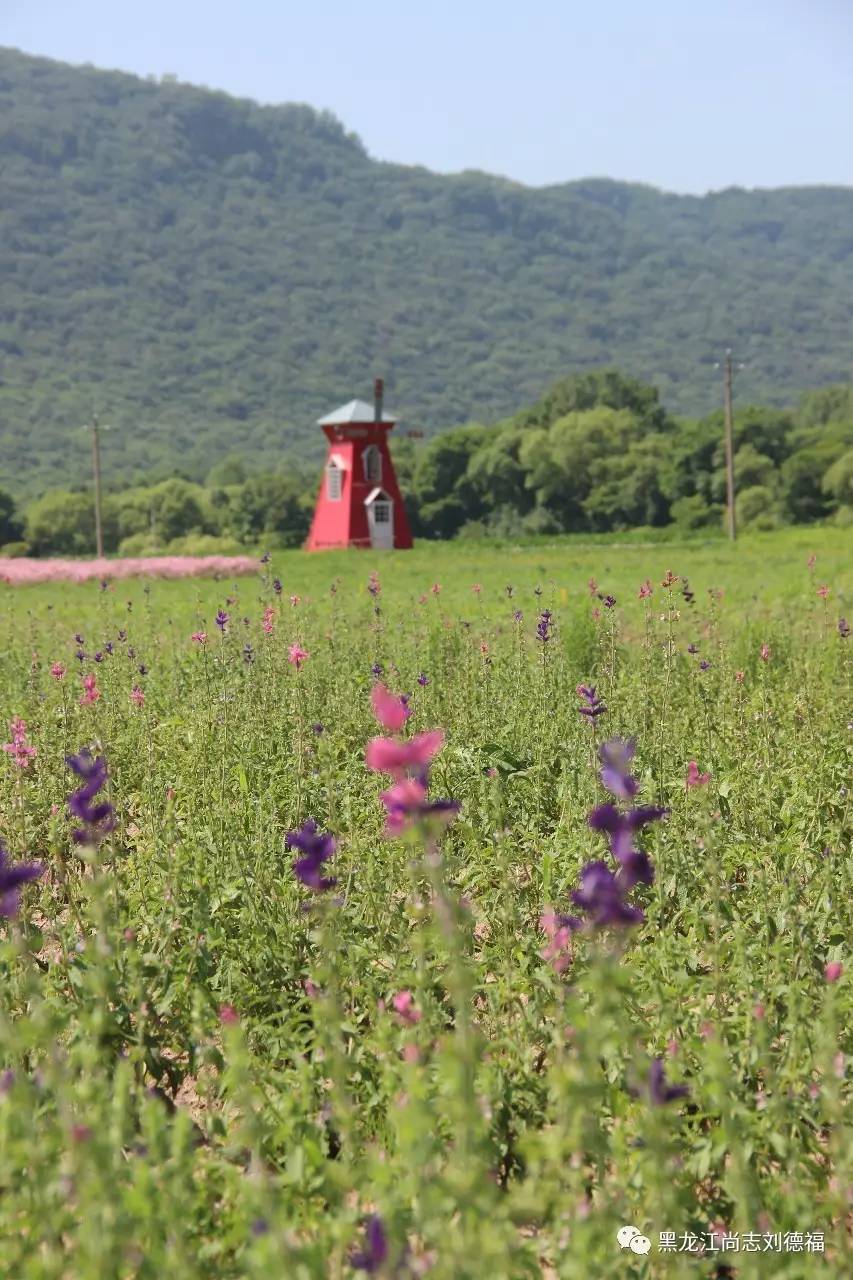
(0, 370, 853, 556)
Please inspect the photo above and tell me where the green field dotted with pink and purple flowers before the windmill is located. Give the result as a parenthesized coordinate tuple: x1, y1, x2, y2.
(0, 529, 853, 1280)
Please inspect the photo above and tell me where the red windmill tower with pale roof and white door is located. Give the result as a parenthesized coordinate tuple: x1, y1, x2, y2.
(305, 378, 411, 552)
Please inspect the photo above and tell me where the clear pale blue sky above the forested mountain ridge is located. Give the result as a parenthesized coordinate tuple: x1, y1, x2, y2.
(0, 0, 853, 192)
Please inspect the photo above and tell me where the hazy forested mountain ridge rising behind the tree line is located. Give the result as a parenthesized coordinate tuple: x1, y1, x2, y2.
(0, 50, 853, 493)
